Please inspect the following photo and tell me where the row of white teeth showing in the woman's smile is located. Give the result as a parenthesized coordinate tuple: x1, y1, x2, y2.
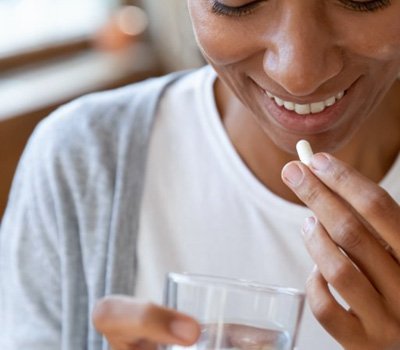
(264, 90, 346, 116)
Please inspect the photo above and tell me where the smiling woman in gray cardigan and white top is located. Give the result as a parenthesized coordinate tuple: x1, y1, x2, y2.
(0, 0, 400, 350)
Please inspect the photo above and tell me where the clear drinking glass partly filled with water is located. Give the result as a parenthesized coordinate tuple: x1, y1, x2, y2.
(165, 273, 304, 350)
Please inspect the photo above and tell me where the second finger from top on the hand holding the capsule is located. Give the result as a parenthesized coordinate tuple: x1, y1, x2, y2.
(283, 162, 400, 304)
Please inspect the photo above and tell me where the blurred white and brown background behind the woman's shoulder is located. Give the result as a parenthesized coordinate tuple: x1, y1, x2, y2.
(0, 0, 204, 221)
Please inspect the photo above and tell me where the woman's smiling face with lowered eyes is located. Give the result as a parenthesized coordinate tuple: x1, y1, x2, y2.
(188, 0, 400, 151)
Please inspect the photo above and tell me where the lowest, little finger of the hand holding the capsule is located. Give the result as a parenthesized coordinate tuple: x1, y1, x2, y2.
(307, 269, 363, 344)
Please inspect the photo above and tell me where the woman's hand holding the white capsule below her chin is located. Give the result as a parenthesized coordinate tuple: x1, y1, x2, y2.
(282, 153, 400, 350)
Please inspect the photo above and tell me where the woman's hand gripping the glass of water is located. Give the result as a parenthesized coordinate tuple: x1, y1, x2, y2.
(92, 295, 200, 350)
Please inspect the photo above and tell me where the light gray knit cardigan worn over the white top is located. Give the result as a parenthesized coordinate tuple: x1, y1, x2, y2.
(0, 74, 185, 350)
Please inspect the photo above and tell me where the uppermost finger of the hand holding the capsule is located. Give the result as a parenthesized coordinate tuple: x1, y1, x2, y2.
(310, 153, 400, 255)
